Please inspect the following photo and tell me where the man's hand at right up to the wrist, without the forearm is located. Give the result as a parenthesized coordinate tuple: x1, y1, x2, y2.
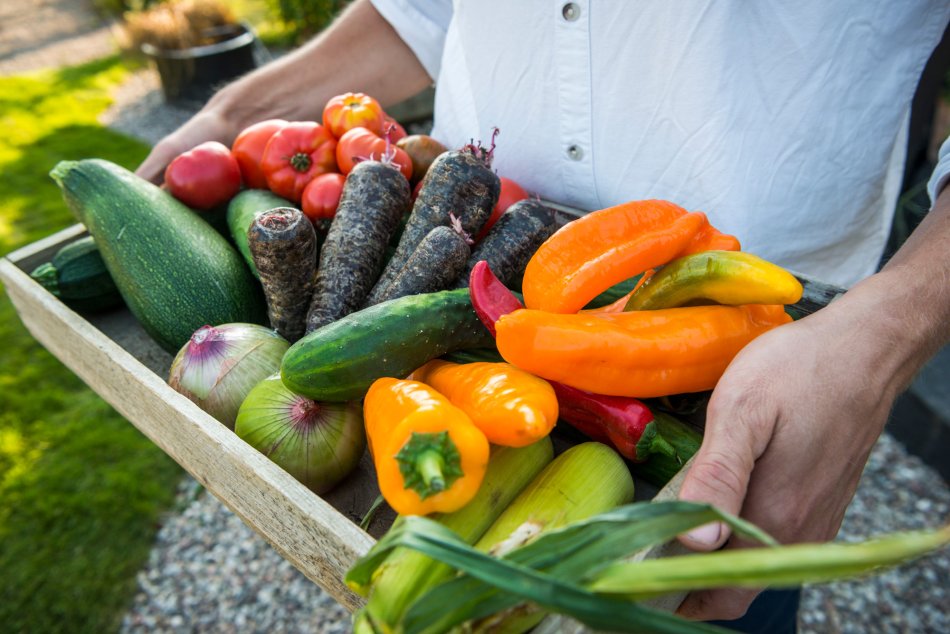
(679, 292, 899, 620)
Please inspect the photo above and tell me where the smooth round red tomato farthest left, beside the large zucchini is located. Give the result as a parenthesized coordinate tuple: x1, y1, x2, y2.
(165, 141, 241, 210)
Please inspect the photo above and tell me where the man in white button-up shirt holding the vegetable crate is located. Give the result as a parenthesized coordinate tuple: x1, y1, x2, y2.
(138, 0, 950, 631)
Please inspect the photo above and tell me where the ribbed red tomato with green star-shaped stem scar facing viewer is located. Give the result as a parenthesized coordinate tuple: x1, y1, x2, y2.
(261, 121, 336, 203)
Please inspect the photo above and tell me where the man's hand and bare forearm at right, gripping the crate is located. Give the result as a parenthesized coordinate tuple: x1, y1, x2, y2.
(679, 181, 950, 620)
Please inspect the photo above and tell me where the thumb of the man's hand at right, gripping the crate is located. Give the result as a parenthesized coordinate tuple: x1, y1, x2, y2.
(679, 434, 755, 550)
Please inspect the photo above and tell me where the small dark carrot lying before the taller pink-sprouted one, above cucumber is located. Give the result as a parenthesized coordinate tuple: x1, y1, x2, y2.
(377, 221, 471, 302)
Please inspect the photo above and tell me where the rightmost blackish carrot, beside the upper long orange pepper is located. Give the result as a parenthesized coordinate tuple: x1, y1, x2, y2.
(458, 200, 558, 289)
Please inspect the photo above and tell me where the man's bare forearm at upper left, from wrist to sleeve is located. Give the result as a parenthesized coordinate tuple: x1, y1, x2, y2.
(209, 0, 431, 142)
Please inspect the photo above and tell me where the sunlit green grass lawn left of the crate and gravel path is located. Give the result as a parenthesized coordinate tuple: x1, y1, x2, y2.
(0, 57, 183, 633)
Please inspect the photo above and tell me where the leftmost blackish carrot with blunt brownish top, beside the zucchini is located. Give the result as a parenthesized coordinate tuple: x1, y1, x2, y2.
(247, 207, 317, 343)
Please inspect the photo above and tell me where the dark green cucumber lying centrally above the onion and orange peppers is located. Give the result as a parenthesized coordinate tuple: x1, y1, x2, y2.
(280, 288, 495, 401)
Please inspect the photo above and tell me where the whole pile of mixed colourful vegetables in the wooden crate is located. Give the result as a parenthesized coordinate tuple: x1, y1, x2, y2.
(41, 93, 950, 632)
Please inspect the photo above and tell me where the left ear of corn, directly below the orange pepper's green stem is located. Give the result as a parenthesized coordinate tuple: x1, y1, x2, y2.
(346, 438, 554, 632)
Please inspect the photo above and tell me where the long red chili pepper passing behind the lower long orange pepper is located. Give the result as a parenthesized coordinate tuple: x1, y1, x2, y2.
(468, 261, 676, 462)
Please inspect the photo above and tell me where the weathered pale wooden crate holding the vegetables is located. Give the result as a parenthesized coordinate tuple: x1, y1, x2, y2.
(0, 225, 712, 631)
